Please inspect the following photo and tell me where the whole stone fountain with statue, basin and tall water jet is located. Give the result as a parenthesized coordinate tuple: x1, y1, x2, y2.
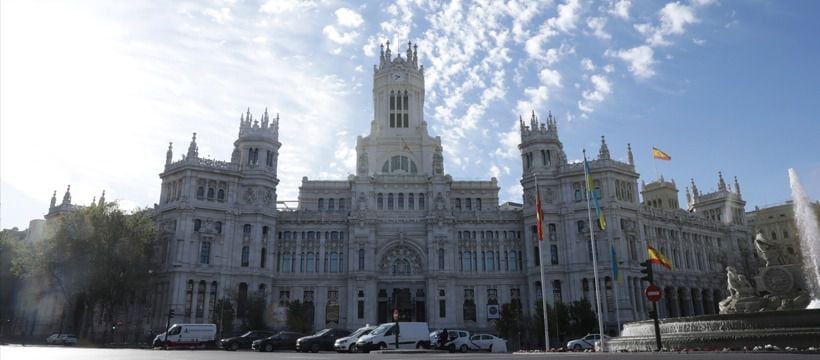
(608, 169, 820, 351)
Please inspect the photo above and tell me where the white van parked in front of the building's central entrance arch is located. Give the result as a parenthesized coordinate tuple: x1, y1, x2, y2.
(356, 322, 430, 352)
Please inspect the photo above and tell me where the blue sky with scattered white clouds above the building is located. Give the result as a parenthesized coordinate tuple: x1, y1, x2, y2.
(0, 0, 820, 229)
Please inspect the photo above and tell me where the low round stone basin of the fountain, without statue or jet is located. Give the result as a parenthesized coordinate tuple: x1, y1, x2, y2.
(608, 309, 820, 351)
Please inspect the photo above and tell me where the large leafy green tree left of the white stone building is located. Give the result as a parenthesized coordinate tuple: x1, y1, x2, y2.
(9, 203, 156, 336)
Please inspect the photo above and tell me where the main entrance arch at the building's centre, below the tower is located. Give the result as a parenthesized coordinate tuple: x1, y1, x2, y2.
(378, 241, 427, 323)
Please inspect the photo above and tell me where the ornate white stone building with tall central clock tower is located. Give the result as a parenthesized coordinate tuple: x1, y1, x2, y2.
(152, 44, 751, 329)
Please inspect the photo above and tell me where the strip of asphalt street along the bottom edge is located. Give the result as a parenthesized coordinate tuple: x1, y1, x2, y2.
(0, 345, 820, 360)
